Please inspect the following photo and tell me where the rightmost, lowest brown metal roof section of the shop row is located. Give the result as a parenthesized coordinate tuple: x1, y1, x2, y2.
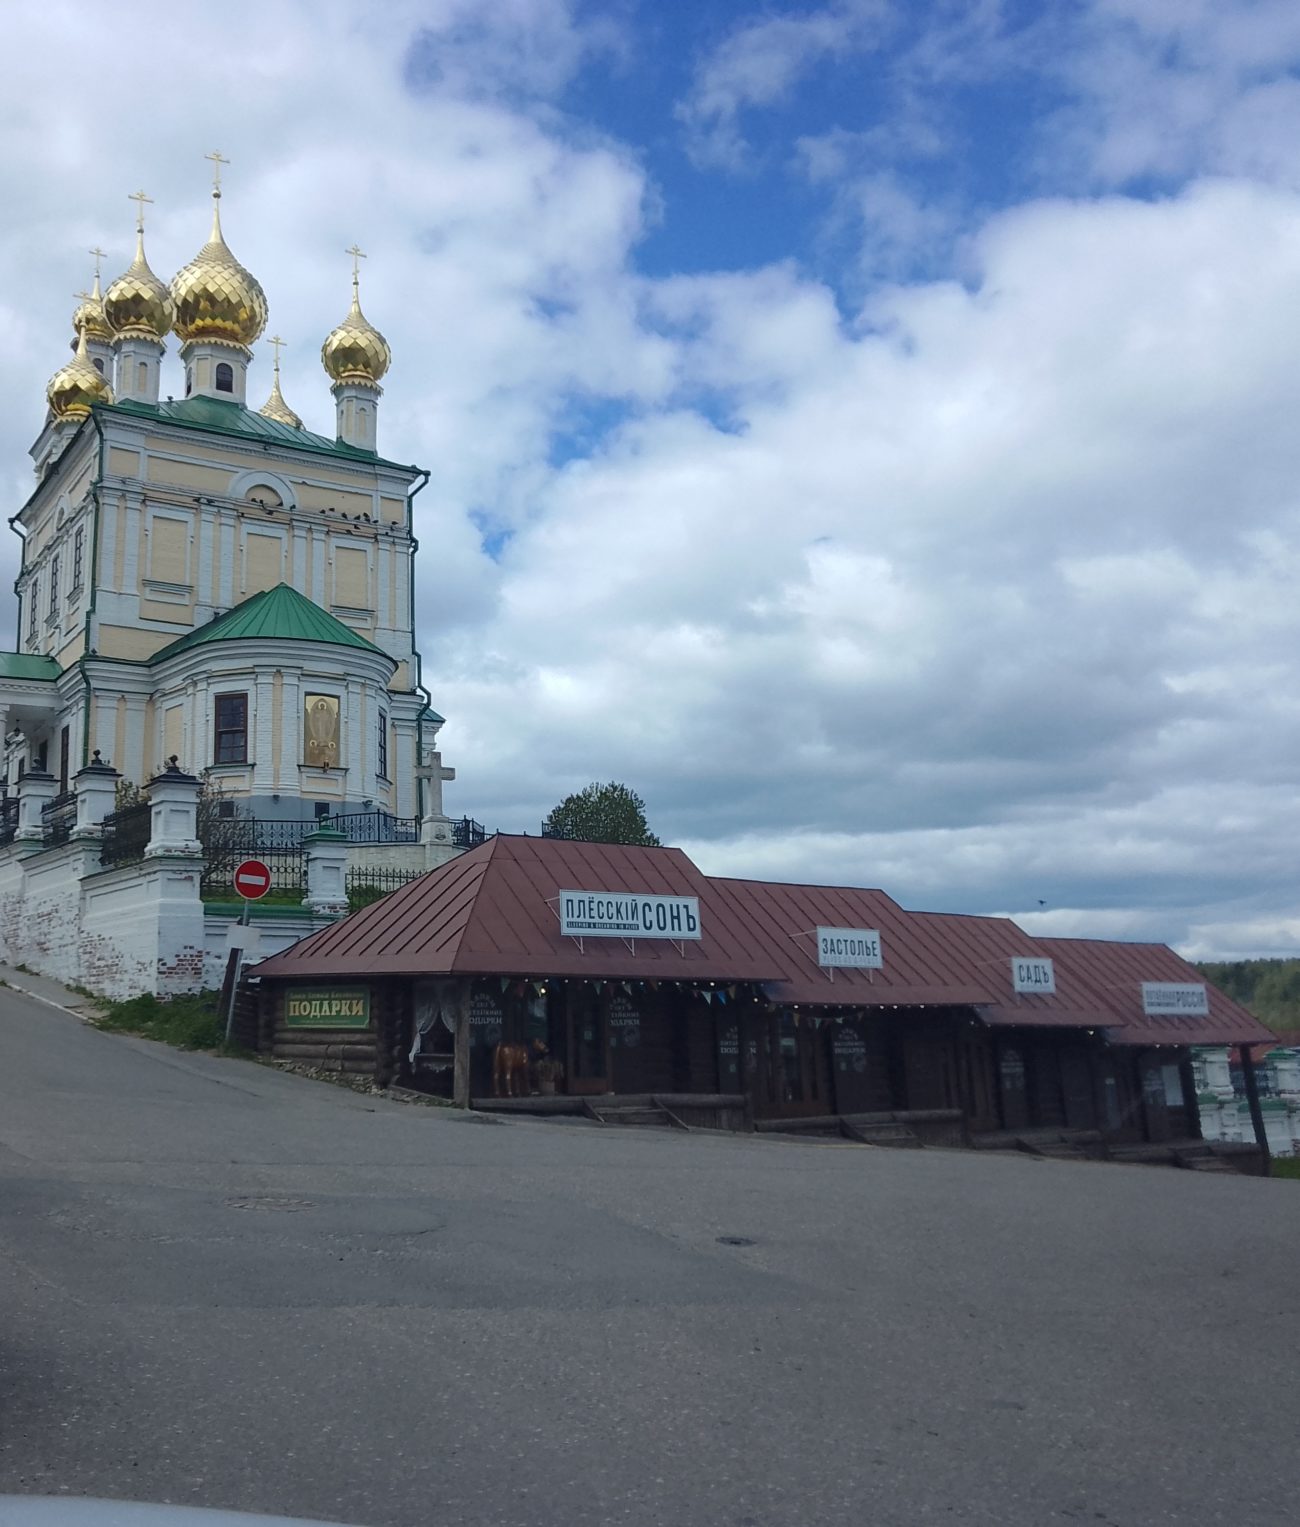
(1034, 939, 1273, 1044)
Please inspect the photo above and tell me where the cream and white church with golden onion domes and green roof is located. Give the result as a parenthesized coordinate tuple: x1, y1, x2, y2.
(0, 156, 449, 820)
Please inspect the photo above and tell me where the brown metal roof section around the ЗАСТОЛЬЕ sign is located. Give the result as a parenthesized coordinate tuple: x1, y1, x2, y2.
(712, 880, 991, 1008)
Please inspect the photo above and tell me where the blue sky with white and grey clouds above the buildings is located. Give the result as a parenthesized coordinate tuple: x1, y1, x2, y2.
(0, 0, 1300, 956)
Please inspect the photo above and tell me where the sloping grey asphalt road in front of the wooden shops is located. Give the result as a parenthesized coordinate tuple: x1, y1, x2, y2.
(0, 991, 1300, 1527)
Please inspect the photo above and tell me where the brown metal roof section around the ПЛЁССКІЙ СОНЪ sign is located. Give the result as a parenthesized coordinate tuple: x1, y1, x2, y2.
(257, 835, 781, 980)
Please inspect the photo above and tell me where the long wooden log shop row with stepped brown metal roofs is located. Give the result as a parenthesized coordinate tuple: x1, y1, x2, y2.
(251, 835, 1268, 1147)
